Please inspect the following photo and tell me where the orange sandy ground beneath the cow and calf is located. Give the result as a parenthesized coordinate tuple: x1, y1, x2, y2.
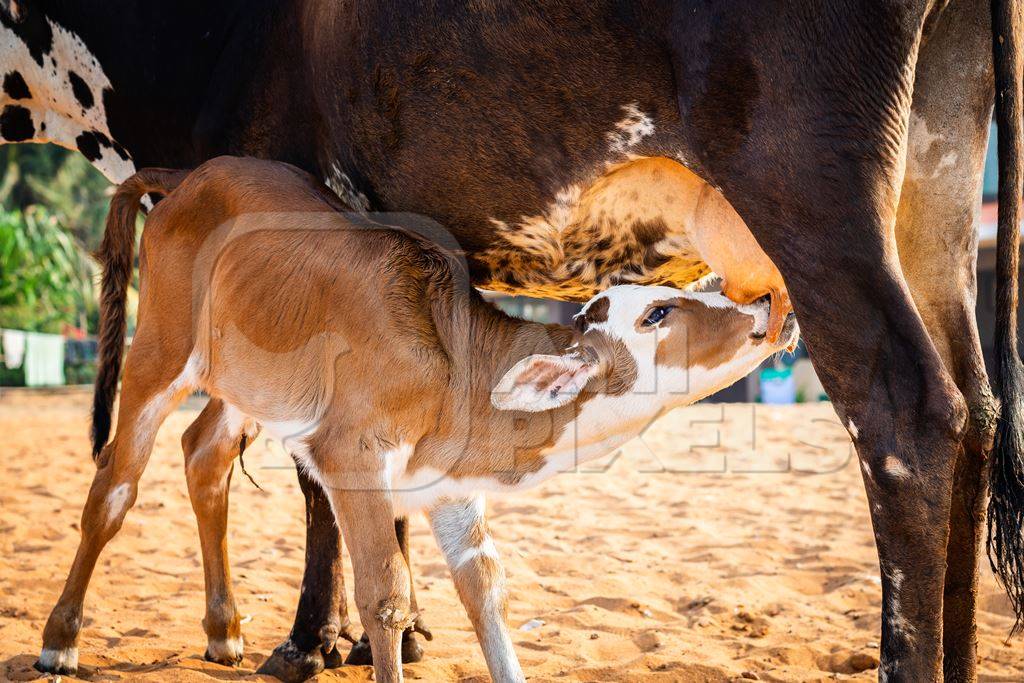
(0, 394, 1024, 682)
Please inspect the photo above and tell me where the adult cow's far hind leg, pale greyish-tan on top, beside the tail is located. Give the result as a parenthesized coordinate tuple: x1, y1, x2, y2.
(896, 1, 996, 681)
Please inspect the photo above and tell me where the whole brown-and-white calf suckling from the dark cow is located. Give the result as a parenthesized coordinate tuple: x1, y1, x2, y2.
(40, 158, 797, 681)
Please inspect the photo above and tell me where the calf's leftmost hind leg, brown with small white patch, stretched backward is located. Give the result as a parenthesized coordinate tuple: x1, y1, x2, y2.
(36, 344, 193, 674)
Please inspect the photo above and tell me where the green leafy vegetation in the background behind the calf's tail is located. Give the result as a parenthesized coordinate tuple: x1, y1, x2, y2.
(0, 144, 111, 334)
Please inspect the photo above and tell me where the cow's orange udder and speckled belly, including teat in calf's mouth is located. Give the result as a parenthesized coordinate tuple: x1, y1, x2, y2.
(477, 157, 793, 342)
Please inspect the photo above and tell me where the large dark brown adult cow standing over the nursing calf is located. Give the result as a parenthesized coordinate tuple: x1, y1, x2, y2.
(8, 0, 1024, 681)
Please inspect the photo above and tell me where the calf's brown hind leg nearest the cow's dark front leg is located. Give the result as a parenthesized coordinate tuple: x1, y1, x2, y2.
(181, 398, 257, 666)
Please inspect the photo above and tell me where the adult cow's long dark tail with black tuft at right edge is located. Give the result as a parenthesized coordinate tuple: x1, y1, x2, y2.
(987, 0, 1024, 633)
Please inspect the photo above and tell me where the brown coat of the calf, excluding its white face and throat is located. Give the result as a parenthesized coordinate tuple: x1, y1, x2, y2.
(44, 158, 763, 680)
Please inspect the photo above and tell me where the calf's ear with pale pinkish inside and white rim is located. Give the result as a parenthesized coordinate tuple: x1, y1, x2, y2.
(490, 355, 598, 413)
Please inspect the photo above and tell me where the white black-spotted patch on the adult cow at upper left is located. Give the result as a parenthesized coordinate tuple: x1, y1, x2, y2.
(0, 14, 135, 183)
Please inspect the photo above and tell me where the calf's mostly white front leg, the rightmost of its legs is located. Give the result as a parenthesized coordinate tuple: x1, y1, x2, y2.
(429, 496, 526, 683)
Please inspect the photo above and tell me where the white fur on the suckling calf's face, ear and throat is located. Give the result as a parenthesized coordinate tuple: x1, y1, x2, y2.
(479, 285, 798, 505)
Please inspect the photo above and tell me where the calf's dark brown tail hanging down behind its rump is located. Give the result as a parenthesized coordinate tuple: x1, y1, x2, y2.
(91, 168, 187, 459)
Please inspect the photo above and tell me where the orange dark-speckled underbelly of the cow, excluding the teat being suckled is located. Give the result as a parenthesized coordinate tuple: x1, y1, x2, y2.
(472, 157, 711, 301)
